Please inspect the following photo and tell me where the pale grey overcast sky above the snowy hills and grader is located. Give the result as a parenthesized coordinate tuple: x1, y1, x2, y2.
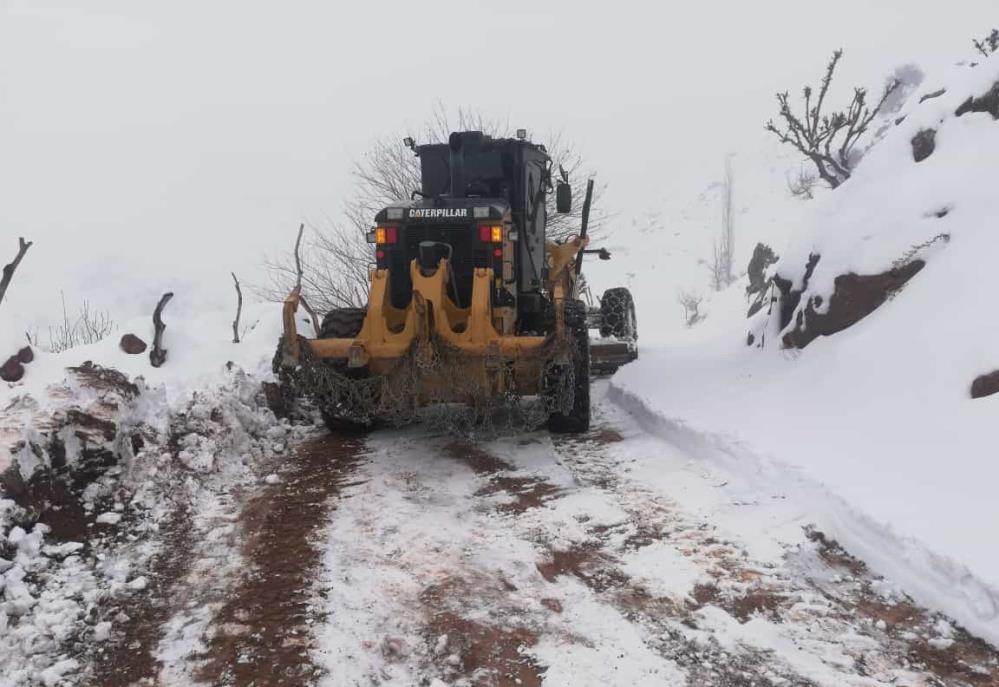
(0, 0, 999, 327)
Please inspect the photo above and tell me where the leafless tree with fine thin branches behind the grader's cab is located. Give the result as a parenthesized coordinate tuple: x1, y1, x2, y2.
(258, 104, 605, 312)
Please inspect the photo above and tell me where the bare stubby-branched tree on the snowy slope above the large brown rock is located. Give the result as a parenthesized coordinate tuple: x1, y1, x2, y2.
(766, 50, 899, 188)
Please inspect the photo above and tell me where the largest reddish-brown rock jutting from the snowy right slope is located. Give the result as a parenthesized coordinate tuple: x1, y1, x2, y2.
(782, 260, 926, 348)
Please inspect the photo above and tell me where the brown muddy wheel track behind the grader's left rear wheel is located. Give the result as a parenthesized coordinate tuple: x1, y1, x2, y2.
(195, 435, 360, 687)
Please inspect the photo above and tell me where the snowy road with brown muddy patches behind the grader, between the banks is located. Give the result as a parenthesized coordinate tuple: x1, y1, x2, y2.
(60, 386, 999, 687)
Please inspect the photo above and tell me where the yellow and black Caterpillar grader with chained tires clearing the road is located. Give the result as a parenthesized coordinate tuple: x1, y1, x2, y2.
(275, 130, 638, 433)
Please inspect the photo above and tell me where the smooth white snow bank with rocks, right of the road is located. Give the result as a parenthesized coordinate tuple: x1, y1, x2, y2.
(613, 53, 999, 643)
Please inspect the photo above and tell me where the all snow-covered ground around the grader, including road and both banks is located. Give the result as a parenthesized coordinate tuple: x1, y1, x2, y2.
(0, 18, 999, 687)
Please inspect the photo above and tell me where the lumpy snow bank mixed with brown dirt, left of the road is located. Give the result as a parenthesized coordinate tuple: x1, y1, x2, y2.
(0, 304, 304, 687)
